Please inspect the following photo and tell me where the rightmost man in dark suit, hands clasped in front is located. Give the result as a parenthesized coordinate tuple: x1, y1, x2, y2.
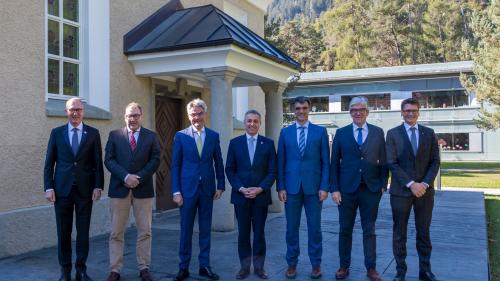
(386, 98, 440, 281)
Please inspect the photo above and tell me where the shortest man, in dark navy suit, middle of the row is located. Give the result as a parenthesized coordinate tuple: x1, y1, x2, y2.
(226, 110, 276, 279)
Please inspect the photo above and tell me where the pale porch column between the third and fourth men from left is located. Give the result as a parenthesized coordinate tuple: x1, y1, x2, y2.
(203, 67, 238, 231)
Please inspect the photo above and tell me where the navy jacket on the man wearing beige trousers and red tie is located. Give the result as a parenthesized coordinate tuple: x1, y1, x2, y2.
(104, 127, 161, 198)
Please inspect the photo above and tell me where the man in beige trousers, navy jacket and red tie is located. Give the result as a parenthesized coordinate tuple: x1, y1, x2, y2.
(104, 102, 161, 281)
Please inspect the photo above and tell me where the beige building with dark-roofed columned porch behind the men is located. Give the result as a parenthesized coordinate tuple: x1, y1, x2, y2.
(0, 0, 298, 258)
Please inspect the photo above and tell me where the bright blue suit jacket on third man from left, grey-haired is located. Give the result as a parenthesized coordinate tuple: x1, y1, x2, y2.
(172, 127, 225, 198)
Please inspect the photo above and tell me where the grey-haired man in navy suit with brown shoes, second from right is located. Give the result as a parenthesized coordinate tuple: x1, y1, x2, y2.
(330, 97, 389, 281)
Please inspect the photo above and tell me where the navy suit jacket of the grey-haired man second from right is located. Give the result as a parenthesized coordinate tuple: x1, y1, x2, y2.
(330, 124, 389, 193)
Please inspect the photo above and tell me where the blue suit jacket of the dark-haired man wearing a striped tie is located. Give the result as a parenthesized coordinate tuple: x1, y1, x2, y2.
(276, 123, 330, 195)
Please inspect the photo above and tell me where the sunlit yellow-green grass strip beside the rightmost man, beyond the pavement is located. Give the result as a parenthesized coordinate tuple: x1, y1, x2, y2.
(441, 171, 500, 188)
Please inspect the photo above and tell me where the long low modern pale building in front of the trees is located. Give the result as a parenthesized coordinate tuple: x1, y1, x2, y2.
(285, 61, 500, 161)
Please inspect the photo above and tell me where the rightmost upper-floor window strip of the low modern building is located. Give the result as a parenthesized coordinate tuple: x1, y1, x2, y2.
(413, 90, 470, 108)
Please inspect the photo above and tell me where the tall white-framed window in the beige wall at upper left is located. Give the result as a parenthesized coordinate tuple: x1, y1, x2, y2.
(46, 0, 81, 96)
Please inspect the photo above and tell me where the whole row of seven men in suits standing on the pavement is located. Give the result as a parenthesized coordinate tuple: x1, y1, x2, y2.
(45, 94, 440, 281)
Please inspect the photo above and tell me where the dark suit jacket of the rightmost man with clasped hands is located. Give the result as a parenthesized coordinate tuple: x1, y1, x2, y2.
(386, 124, 440, 197)
